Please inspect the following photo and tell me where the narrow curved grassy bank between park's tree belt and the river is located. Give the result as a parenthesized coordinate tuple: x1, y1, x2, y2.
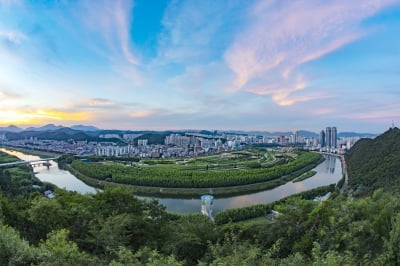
(65, 157, 325, 199)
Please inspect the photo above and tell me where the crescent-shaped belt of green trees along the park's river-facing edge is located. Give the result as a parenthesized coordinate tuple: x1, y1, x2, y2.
(72, 153, 321, 188)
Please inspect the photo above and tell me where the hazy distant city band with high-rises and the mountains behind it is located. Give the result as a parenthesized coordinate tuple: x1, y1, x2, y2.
(0, 125, 373, 158)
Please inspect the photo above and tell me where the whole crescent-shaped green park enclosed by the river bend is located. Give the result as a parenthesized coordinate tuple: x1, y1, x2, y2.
(59, 149, 323, 196)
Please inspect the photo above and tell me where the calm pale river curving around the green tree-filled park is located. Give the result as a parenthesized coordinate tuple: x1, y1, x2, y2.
(0, 149, 342, 214)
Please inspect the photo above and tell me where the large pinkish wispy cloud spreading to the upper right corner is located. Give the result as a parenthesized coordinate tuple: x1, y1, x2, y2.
(225, 0, 396, 105)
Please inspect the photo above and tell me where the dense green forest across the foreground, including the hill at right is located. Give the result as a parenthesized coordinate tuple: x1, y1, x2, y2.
(0, 129, 400, 265)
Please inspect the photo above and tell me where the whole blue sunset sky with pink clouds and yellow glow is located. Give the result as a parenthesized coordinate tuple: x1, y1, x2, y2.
(0, 0, 400, 133)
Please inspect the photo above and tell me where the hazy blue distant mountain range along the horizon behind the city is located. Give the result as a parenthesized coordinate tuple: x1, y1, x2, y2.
(0, 124, 377, 142)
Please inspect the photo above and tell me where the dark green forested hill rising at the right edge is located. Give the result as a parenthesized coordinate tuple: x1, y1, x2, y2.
(346, 128, 400, 193)
